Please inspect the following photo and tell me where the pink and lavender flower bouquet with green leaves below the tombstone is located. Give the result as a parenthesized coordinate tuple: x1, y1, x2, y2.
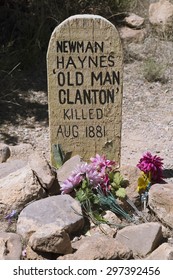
(61, 154, 131, 223)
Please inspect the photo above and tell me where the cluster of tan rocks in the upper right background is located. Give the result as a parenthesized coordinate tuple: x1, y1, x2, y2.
(119, 0, 173, 43)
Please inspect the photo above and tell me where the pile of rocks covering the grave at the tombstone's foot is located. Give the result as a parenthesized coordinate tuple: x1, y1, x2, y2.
(0, 145, 173, 260)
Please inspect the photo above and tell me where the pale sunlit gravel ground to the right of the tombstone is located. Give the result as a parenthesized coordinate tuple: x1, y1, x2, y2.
(122, 38, 173, 169)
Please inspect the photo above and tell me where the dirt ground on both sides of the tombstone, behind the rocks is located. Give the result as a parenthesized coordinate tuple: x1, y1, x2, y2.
(0, 36, 173, 176)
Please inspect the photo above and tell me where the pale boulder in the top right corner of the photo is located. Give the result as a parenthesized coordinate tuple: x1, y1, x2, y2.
(149, 0, 173, 38)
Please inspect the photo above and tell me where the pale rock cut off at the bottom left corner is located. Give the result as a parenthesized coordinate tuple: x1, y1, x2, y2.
(0, 232, 22, 260)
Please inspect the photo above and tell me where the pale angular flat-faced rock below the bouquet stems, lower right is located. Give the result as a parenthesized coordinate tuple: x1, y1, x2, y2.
(115, 223, 163, 256)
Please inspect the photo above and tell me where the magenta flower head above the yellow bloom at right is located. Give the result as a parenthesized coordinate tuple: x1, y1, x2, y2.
(137, 152, 163, 181)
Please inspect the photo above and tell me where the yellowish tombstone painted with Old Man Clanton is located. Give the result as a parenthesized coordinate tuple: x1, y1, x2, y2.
(47, 15, 123, 167)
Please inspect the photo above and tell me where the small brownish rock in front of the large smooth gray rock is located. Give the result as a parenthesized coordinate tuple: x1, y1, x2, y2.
(28, 224, 72, 255)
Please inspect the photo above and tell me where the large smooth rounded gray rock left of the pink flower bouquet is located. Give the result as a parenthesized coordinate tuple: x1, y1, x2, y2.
(17, 195, 84, 240)
